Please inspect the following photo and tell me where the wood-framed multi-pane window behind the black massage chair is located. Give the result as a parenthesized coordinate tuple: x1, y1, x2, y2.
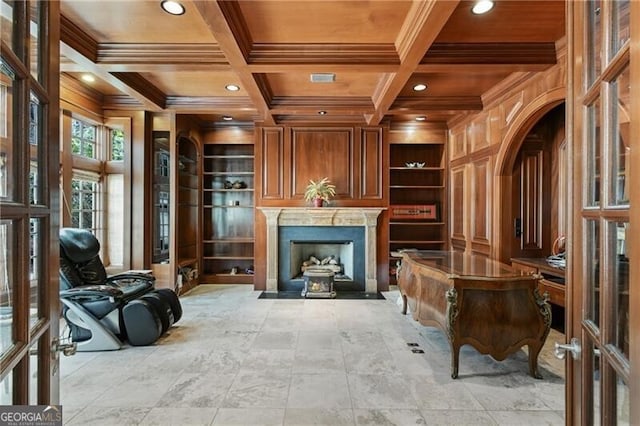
(60, 111, 130, 272)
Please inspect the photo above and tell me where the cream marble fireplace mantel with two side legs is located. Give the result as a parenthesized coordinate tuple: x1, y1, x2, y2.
(258, 207, 384, 293)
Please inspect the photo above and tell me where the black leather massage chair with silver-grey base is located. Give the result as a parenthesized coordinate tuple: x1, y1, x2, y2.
(60, 228, 182, 351)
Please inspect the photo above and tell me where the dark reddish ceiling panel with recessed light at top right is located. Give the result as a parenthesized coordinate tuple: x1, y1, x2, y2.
(436, 0, 565, 43)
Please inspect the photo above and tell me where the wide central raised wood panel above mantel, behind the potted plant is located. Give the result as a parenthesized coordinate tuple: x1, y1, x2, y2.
(291, 128, 354, 198)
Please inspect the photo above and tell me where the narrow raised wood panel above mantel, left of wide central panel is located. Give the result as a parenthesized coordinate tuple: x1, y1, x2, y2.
(260, 129, 284, 200)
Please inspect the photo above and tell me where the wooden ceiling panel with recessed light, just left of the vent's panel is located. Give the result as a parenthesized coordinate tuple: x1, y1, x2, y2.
(140, 71, 247, 97)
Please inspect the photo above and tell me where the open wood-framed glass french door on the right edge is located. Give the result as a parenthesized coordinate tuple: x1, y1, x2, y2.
(567, 0, 640, 425)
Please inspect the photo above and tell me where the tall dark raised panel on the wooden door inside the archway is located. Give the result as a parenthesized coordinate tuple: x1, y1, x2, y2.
(520, 151, 543, 250)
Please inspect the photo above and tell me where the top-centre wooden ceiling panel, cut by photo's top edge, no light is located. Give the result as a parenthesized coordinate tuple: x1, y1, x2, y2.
(239, 0, 412, 43)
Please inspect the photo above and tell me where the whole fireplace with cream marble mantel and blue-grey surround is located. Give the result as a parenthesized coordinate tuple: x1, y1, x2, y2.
(258, 207, 383, 293)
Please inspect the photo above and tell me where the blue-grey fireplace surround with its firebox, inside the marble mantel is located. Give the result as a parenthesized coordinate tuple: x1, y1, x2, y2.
(278, 226, 365, 293)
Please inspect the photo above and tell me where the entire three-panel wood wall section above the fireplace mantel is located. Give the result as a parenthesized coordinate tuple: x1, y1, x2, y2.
(256, 126, 386, 207)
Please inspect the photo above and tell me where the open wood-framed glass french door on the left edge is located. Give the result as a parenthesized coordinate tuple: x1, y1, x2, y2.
(0, 0, 60, 405)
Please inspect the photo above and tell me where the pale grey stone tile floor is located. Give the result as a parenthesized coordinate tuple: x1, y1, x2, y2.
(61, 285, 564, 426)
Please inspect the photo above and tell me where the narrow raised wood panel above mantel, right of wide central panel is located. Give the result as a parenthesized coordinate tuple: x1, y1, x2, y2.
(360, 129, 383, 199)
